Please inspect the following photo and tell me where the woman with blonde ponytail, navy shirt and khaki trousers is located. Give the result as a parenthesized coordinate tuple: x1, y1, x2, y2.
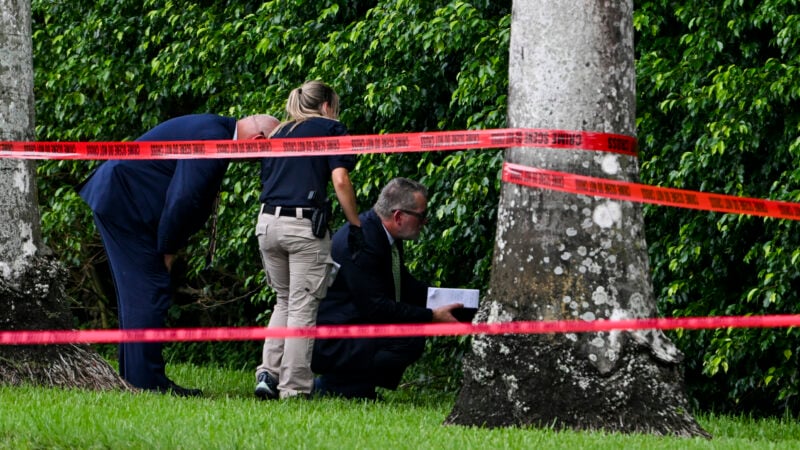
(255, 81, 361, 399)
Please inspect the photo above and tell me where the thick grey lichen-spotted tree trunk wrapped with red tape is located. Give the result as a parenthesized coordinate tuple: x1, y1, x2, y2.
(445, 0, 709, 437)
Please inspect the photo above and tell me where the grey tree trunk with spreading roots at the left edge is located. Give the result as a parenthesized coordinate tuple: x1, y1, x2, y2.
(0, 0, 127, 389)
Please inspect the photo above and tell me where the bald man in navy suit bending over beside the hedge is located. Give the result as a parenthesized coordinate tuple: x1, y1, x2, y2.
(79, 114, 279, 396)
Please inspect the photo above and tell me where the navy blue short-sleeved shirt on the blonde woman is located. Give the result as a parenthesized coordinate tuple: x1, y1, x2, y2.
(260, 117, 356, 208)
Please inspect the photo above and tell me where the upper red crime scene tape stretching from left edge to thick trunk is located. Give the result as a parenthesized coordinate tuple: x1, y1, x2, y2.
(0, 128, 637, 159)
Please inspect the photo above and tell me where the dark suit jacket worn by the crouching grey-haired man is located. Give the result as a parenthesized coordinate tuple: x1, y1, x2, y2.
(312, 210, 433, 373)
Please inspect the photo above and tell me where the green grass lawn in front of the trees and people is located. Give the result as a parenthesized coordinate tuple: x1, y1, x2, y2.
(0, 365, 800, 450)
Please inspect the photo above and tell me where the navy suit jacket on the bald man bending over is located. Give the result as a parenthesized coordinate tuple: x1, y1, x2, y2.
(79, 114, 236, 254)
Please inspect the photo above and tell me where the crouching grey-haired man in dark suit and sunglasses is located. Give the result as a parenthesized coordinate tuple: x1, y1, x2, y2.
(311, 178, 463, 399)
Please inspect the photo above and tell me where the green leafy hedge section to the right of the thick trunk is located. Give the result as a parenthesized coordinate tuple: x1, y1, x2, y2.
(635, 0, 800, 412)
